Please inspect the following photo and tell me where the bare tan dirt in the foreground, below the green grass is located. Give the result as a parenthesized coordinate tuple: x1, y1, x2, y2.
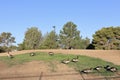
(0, 61, 79, 80)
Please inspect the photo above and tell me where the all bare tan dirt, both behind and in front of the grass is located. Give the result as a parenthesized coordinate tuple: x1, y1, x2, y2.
(0, 49, 120, 80)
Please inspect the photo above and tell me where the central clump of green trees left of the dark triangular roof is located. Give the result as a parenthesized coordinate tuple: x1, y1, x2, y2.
(19, 22, 90, 50)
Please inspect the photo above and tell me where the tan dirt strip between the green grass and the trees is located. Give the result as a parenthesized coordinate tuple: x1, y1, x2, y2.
(0, 49, 120, 65)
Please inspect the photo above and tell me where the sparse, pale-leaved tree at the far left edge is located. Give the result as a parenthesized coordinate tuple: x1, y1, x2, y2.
(0, 32, 15, 53)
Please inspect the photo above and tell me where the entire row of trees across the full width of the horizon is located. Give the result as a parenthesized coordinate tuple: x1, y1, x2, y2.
(0, 22, 120, 52)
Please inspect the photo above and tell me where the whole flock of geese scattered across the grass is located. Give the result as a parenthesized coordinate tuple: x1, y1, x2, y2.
(8, 52, 118, 74)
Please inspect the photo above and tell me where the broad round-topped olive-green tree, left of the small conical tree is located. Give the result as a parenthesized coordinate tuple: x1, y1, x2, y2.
(23, 27, 42, 49)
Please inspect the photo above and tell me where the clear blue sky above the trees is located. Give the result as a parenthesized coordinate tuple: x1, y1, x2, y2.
(0, 0, 120, 44)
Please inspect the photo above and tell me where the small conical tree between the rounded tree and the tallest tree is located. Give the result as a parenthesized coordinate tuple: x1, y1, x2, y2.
(40, 31, 58, 49)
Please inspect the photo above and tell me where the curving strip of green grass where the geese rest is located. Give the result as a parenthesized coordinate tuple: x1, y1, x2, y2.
(0, 52, 120, 75)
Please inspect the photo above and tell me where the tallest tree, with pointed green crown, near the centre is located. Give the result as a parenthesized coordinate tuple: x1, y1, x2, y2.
(59, 22, 81, 49)
